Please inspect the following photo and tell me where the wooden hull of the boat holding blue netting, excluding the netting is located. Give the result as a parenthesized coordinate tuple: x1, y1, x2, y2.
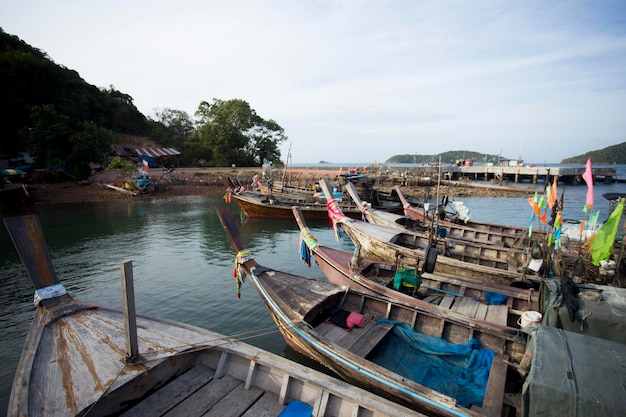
(218, 207, 526, 416)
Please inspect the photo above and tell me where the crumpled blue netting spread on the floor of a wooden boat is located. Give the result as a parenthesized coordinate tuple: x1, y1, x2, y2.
(368, 319, 494, 407)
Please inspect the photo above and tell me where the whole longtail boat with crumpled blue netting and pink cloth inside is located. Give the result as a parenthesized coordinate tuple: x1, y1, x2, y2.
(217, 206, 530, 416)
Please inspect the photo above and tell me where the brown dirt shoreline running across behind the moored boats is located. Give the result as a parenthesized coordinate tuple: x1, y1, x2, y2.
(23, 168, 534, 204)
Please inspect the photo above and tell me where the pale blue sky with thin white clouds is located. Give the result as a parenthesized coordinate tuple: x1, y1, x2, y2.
(0, 0, 626, 164)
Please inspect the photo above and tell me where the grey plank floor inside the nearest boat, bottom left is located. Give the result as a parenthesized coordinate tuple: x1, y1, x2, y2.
(123, 364, 286, 417)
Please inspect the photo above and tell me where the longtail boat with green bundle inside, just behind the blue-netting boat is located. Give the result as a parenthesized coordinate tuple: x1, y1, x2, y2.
(293, 207, 539, 329)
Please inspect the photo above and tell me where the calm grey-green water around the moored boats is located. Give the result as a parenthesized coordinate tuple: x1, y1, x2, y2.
(0, 171, 626, 410)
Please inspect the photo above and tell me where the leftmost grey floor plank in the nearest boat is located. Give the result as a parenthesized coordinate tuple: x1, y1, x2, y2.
(122, 365, 214, 417)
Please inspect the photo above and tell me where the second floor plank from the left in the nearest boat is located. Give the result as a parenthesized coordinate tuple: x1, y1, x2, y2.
(165, 375, 241, 417)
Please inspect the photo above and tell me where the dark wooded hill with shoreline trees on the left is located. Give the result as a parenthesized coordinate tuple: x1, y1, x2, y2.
(0, 28, 287, 178)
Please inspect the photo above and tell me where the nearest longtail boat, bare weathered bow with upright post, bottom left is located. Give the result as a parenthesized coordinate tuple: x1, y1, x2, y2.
(5, 216, 415, 417)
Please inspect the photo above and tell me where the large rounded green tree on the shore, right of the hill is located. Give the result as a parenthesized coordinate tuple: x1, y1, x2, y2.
(192, 98, 287, 166)
